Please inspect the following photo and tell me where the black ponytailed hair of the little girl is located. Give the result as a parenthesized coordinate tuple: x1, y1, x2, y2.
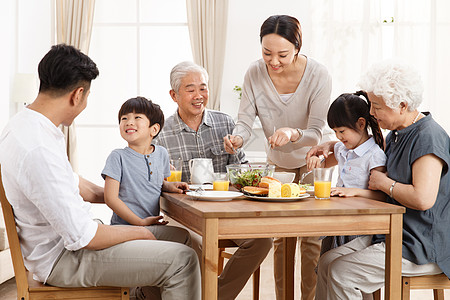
(327, 91, 384, 149)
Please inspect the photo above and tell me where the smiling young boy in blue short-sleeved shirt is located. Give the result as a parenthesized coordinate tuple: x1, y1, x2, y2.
(102, 97, 188, 226)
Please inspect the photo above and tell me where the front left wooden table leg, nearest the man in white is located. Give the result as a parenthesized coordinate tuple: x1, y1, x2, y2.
(202, 219, 219, 300)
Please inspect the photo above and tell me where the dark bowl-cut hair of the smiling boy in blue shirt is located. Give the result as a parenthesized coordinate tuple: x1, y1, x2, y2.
(119, 97, 164, 138)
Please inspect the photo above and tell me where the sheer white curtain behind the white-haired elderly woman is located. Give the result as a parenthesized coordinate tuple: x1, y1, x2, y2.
(304, 0, 450, 133)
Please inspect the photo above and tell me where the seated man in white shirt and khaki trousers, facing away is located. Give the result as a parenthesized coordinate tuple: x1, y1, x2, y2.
(0, 45, 201, 299)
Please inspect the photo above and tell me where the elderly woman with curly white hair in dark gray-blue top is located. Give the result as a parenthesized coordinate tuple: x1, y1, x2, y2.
(307, 62, 450, 300)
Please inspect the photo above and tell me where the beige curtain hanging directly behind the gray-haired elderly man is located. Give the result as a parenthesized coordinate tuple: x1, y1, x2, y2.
(186, 0, 228, 110)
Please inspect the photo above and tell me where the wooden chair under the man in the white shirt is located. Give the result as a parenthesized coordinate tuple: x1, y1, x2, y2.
(0, 166, 129, 300)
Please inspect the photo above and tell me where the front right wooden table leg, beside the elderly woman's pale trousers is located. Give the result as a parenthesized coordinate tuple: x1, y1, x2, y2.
(385, 214, 403, 299)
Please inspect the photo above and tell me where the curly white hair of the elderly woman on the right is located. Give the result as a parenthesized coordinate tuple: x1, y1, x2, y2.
(358, 60, 423, 111)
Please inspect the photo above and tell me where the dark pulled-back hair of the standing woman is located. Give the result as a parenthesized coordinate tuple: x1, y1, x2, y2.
(259, 15, 302, 56)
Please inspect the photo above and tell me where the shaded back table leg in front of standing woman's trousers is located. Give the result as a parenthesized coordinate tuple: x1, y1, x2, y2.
(283, 237, 297, 300)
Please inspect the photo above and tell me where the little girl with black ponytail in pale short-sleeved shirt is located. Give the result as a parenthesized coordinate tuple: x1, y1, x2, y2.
(307, 91, 386, 253)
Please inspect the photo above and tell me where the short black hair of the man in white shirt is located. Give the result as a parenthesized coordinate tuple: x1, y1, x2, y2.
(38, 44, 99, 96)
